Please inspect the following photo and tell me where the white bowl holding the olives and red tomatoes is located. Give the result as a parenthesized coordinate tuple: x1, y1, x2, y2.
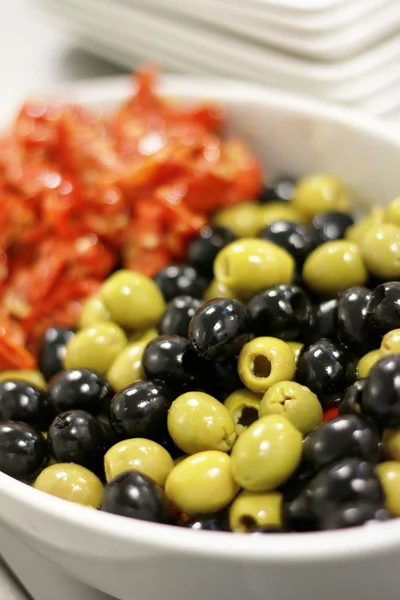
(0, 77, 400, 600)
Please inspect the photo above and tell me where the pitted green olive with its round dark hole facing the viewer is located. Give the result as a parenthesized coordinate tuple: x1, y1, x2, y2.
(238, 337, 296, 394)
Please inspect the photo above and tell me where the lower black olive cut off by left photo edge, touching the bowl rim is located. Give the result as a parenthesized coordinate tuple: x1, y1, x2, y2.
(0, 421, 49, 481)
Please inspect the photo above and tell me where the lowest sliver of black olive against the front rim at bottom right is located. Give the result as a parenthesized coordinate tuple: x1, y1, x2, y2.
(321, 502, 395, 529)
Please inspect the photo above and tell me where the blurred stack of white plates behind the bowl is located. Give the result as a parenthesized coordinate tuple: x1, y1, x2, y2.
(40, 0, 400, 119)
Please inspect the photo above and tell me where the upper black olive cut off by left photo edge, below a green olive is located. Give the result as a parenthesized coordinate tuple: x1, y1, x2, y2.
(0, 380, 56, 430)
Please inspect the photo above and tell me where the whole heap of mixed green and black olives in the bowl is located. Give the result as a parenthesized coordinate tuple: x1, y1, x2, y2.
(0, 174, 400, 534)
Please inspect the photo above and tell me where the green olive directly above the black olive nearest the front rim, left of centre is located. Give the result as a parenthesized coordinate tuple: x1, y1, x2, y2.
(104, 438, 174, 486)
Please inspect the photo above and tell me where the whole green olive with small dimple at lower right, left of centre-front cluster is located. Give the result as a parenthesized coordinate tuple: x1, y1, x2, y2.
(168, 392, 236, 454)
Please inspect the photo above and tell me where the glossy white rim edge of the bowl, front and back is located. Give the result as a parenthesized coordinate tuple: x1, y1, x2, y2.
(0, 75, 400, 563)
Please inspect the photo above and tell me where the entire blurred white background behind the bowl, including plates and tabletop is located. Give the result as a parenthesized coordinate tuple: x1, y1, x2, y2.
(0, 0, 400, 125)
